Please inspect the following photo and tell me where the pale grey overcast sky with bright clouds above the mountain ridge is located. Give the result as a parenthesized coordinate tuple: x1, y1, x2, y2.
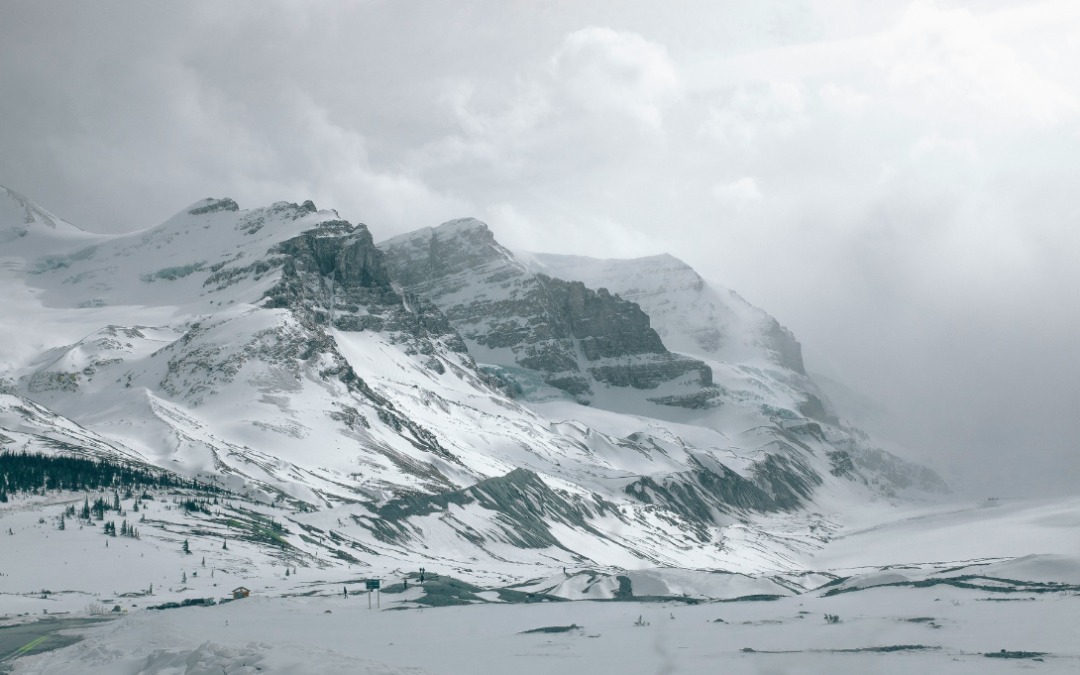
(0, 0, 1080, 496)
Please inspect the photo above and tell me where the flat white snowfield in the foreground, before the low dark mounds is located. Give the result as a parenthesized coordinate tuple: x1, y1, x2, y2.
(8, 588, 1080, 675)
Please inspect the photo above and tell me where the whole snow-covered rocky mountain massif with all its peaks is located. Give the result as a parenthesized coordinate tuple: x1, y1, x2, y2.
(0, 190, 945, 570)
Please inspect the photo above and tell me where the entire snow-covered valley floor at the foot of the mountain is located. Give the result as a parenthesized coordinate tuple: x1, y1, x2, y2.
(0, 498, 1080, 675)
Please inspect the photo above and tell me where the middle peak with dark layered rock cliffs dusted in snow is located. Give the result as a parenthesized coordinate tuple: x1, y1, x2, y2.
(379, 218, 712, 405)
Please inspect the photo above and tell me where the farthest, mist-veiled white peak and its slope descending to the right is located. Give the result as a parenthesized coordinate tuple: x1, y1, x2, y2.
(514, 247, 944, 490)
